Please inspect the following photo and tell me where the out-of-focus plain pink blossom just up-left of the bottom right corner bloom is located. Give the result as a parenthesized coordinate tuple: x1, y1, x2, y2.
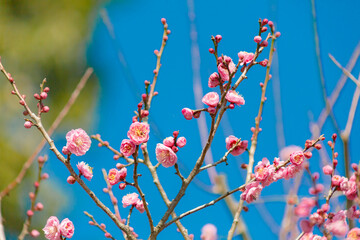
(324, 210, 349, 237)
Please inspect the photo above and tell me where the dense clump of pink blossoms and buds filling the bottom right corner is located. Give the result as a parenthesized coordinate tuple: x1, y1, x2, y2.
(294, 134, 360, 240)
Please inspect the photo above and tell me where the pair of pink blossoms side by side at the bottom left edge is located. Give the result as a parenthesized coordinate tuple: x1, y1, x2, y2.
(43, 216, 75, 240)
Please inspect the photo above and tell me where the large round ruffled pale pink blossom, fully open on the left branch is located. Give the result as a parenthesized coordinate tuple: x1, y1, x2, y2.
(63, 128, 91, 156)
